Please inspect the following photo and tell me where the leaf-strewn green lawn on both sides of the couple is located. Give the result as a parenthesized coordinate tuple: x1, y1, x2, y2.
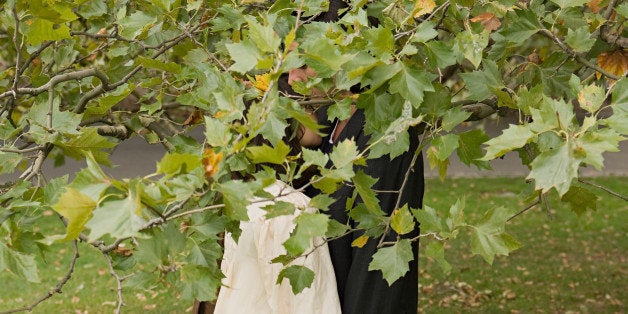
(0, 177, 628, 313)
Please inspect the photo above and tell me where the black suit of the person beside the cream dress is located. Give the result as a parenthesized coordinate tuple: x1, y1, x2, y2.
(312, 109, 424, 314)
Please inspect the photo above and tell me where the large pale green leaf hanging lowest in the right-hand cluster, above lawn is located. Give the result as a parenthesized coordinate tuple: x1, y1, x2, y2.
(526, 142, 580, 196)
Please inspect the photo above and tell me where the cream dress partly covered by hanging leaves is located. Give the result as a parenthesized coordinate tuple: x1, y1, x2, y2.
(215, 181, 341, 314)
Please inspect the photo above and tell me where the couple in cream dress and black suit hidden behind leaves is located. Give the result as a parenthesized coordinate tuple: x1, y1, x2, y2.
(210, 69, 423, 314)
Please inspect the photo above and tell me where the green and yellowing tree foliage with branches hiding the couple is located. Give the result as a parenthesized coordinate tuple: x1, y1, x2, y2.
(0, 0, 628, 310)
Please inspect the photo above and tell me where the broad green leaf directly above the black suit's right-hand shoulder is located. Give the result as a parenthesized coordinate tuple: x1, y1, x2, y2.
(388, 64, 434, 108)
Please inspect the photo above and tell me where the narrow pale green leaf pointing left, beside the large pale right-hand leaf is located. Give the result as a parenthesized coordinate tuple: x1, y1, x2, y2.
(481, 124, 535, 161)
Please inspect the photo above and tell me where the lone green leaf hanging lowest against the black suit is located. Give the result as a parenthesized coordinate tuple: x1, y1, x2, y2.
(369, 239, 414, 286)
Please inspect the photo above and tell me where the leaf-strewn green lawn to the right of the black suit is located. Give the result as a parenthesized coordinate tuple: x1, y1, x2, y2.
(419, 177, 628, 313)
